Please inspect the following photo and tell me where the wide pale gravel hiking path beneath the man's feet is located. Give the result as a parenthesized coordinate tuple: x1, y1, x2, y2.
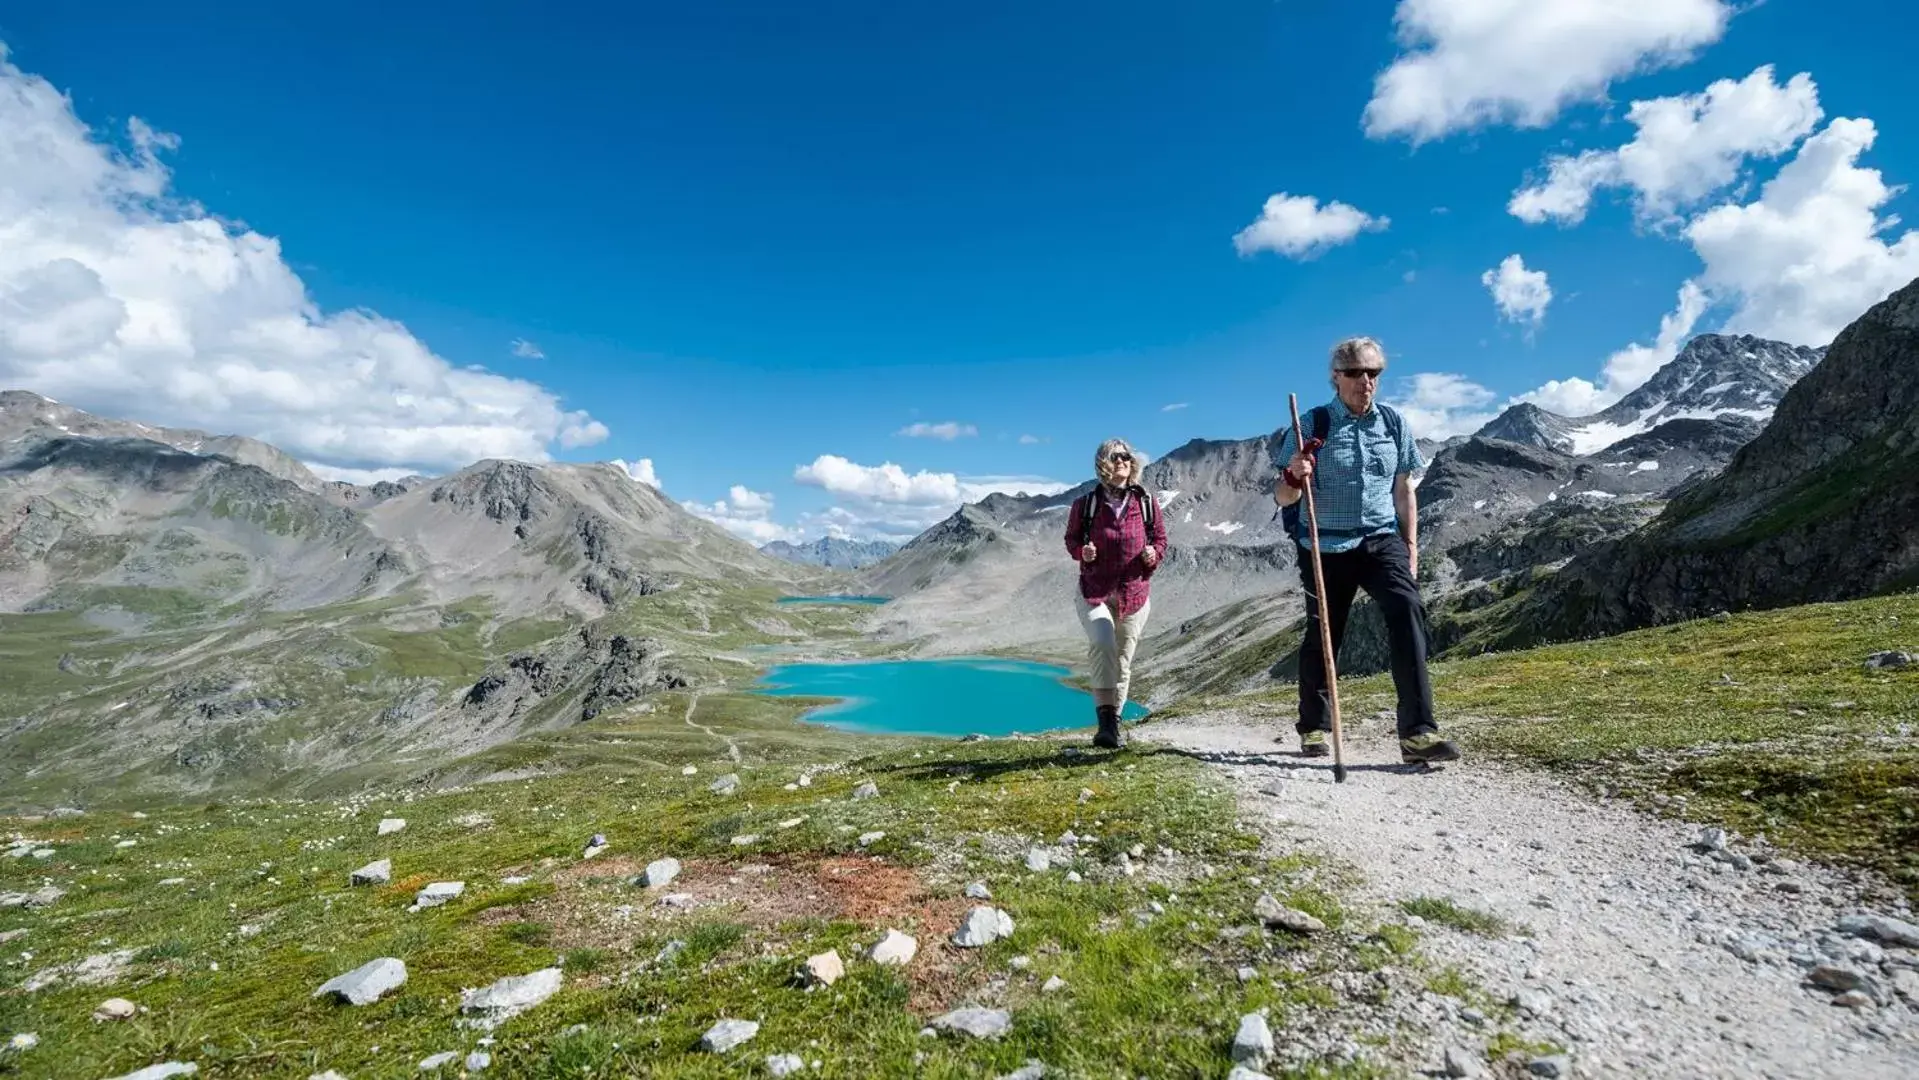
(1132, 710, 1919, 1080)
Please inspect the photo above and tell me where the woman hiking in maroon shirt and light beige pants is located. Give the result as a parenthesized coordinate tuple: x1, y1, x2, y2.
(1065, 439, 1167, 750)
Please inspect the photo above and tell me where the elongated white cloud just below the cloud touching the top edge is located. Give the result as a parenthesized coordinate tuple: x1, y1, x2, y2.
(1506, 63, 1823, 224)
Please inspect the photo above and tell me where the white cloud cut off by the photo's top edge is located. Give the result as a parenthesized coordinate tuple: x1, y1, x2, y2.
(1364, 0, 1733, 142)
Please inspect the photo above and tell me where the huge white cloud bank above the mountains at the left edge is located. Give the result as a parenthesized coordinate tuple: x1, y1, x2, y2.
(0, 46, 608, 474)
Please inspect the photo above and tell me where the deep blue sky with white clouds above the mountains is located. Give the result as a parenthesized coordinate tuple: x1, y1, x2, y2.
(0, 0, 1919, 539)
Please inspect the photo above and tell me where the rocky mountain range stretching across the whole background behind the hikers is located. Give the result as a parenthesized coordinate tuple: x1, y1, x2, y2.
(0, 284, 1919, 798)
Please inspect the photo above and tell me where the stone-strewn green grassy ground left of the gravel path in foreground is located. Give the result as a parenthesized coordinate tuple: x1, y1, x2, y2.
(0, 694, 1503, 1080)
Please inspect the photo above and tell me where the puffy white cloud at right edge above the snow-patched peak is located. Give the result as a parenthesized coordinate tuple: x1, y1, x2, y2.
(1685, 117, 1919, 345)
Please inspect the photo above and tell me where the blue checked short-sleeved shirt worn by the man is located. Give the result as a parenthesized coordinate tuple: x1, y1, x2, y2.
(1276, 397, 1426, 551)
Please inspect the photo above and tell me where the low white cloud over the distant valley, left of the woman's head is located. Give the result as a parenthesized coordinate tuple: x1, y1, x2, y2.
(793, 455, 1073, 539)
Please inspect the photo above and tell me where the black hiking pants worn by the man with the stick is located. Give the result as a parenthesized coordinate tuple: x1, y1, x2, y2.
(1297, 533, 1439, 739)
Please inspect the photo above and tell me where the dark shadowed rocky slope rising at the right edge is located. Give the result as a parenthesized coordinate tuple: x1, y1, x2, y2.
(1506, 274, 1919, 643)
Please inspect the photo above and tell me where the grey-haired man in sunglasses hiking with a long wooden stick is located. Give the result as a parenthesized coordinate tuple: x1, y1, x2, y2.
(1272, 338, 1458, 763)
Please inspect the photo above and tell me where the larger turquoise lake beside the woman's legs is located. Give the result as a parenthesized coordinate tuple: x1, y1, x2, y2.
(754, 658, 1148, 737)
